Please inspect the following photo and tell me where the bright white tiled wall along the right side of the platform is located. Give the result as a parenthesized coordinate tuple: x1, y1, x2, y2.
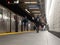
(48, 0, 60, 32)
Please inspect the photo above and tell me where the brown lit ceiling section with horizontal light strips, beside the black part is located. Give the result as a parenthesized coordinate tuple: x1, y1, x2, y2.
(20, 0, 46, 22)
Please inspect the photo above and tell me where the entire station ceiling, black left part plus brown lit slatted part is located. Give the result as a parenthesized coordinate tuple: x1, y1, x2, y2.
(0, 0, 46, 22)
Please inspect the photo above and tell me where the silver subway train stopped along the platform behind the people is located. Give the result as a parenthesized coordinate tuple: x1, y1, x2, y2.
(0, 5, 34, 32)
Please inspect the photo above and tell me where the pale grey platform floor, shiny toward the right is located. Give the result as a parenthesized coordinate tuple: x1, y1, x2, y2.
(0, 31, 60, 45)
